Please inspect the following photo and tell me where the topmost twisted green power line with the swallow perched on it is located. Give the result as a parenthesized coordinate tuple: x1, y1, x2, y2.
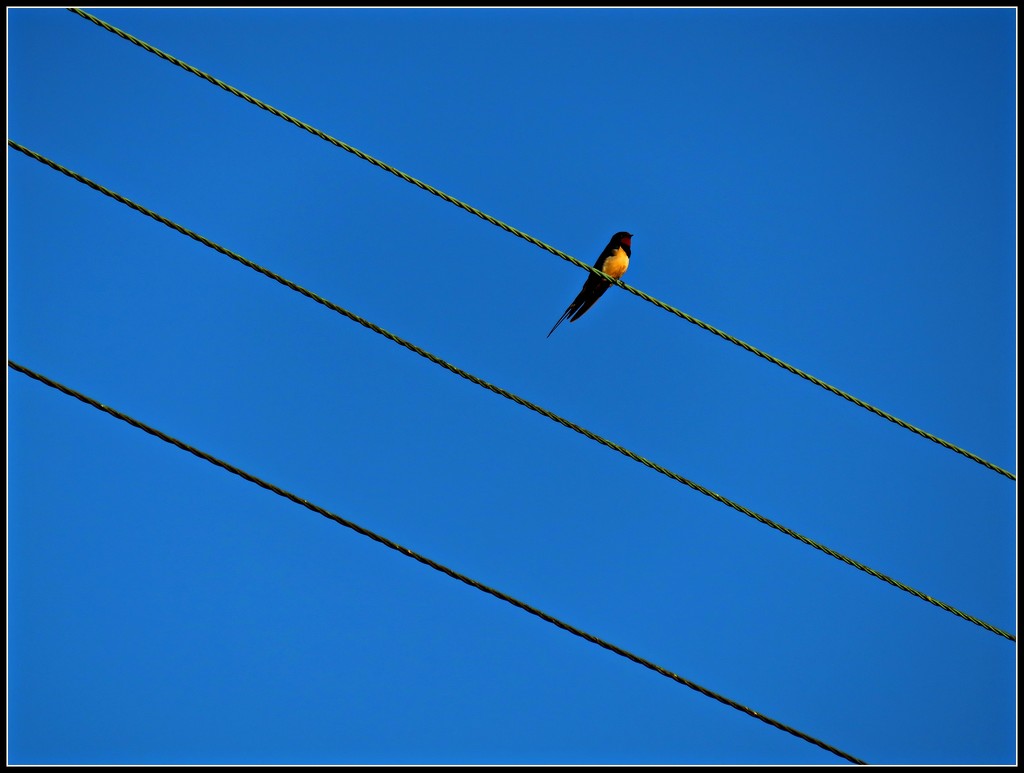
(68, 8, 1017, 480)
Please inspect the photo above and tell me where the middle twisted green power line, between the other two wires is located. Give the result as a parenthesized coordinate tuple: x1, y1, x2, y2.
(7, 139, 1016, 641)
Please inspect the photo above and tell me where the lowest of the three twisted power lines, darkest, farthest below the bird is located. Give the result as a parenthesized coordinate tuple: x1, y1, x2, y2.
(7, 359, 867, 765)
